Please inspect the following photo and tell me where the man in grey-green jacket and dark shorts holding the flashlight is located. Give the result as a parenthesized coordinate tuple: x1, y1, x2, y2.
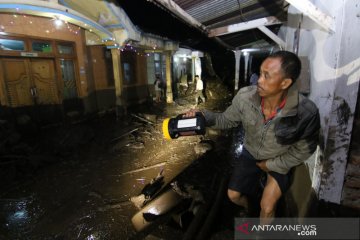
(185, 51, 320, 224)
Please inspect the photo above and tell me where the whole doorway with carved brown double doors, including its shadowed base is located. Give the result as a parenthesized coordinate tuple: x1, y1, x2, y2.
(0, 57, 62, 124)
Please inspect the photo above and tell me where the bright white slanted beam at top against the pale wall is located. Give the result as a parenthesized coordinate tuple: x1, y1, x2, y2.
(286, 0, 335, 33)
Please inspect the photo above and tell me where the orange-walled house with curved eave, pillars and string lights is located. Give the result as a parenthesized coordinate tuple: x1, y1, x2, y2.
(0, 0, 205, 123)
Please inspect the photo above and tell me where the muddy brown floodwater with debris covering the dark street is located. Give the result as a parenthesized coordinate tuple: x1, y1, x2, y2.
(0, 79, 241, 240)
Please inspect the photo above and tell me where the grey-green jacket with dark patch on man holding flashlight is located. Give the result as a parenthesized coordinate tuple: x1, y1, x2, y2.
(204, 84, 320, 174)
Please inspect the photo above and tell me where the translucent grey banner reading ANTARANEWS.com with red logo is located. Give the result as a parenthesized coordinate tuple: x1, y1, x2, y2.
(235, 218, 360, 239)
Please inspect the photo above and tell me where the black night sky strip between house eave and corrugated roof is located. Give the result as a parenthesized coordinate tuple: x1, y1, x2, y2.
(118, 0, 235, 82)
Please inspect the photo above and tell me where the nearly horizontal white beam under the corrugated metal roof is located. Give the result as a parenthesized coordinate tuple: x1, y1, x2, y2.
(208, 17, 282, 37)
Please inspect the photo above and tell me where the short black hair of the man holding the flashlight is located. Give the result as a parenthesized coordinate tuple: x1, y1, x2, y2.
(269, 51, 301, 83)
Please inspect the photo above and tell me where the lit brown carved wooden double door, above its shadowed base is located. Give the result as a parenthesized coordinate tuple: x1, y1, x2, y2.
(1, 58, 59, 107)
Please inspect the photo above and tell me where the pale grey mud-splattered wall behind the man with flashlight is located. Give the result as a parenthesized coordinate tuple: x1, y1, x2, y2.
(280, 0, 360, 208)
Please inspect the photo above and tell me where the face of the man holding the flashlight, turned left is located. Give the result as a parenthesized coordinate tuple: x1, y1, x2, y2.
(257, 58, 291, 97)
